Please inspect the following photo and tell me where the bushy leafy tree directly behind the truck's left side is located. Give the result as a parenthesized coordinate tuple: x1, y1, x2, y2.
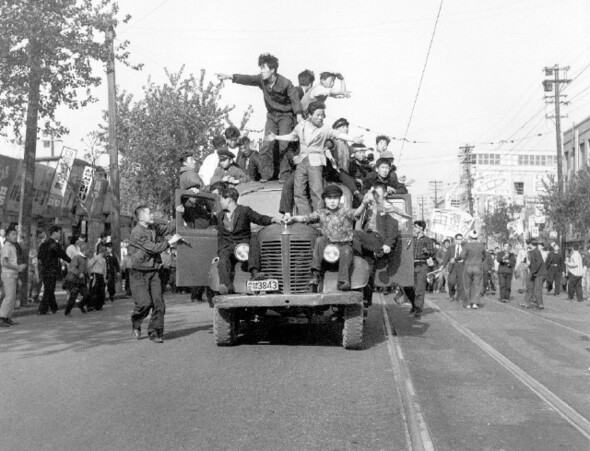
(114, 68, 252, 219)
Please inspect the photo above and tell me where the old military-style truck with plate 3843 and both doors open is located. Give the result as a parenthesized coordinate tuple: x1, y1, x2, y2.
(176, 182, 414, 349)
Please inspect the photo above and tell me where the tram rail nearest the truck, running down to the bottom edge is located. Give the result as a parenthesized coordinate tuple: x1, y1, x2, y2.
(376, 294, 435, 451)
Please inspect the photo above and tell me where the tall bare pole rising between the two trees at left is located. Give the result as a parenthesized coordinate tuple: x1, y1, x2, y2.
(106, 25, 121, 289)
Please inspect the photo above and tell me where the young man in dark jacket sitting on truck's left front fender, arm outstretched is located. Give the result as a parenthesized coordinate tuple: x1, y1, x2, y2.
(217, 187, 281, 294)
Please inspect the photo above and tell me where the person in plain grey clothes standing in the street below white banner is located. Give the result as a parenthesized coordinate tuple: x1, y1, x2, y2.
(459, 230, 488, 309)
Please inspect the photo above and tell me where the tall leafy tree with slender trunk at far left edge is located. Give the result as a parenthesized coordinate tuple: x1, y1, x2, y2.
(0, 0, 135, 296)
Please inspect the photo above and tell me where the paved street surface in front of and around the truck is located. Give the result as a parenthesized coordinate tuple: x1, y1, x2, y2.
(0, 288, 590, 450)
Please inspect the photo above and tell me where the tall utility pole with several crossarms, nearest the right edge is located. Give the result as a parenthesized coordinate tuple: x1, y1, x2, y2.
(543, 64, 571, 249)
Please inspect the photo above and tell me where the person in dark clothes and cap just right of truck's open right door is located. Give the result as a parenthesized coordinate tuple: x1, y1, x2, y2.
(403, 220, 435, 319)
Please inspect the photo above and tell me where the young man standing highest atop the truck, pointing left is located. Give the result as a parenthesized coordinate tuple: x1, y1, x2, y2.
(217, 53, 303, 182)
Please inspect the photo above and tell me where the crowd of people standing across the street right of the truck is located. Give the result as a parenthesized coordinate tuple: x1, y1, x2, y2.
(418, 231, 590, 310)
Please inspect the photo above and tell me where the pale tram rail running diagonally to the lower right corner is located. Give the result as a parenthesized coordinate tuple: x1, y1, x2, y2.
(426, 300, 590, 440)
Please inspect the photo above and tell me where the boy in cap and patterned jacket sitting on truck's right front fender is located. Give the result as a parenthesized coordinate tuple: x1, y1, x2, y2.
(287, 185, 369, 291)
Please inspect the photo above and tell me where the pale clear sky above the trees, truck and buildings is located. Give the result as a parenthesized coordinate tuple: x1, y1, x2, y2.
(52, 0, 590, 200)
